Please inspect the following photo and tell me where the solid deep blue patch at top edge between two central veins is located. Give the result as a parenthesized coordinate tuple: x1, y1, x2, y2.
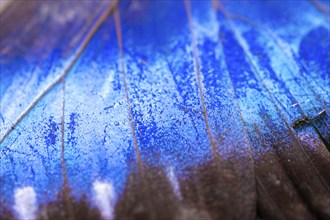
(120, 0, 187, 51)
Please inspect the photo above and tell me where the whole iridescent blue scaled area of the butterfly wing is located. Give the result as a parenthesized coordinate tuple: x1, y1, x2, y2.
(0, 1, 330, 217)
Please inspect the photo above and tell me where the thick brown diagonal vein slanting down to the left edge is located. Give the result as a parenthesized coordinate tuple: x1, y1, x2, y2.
(0, 0, 119, 143)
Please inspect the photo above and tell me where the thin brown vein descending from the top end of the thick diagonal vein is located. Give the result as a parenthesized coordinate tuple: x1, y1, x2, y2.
(114, 8, 157, 220)
